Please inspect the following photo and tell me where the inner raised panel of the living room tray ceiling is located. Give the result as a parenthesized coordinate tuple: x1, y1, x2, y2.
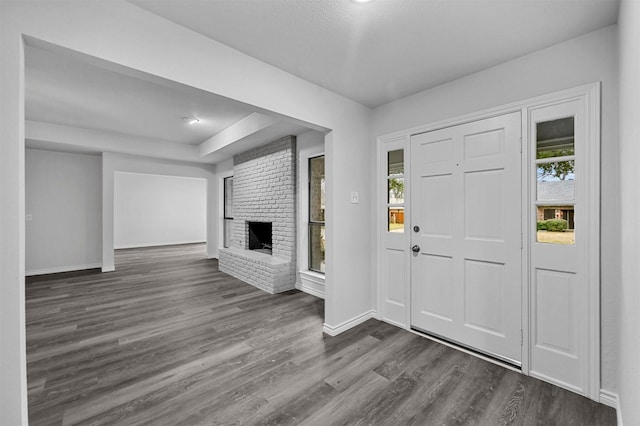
(25, 45, 260, 145)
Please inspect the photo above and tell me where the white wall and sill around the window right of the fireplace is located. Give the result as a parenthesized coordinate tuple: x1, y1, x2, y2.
(296, 130, 324, 297)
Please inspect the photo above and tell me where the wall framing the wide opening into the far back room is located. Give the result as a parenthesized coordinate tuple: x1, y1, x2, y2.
(102, 153, 218, 272)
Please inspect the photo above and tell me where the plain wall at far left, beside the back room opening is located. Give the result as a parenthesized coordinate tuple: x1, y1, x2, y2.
(25, 149, 102, 275)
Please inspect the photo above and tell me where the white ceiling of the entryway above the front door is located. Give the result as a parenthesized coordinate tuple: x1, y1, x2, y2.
(130, 0, 618, 107)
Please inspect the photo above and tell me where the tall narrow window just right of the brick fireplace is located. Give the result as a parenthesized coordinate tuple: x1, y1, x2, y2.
(309, 155, 325, 274)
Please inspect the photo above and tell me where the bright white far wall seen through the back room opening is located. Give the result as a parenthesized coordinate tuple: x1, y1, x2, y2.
(114, 172, 207, 249)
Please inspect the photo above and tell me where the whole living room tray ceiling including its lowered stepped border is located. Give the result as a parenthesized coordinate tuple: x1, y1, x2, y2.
(25, 40, 310, 163)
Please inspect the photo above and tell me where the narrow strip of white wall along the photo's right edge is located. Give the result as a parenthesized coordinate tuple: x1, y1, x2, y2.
(616, 0, 640, 425)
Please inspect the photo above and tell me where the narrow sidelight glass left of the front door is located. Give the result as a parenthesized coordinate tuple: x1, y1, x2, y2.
(387, 149, 404, 232)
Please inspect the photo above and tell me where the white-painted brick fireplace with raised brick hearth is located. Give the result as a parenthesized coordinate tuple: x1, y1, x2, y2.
(219, 136, 296, 293)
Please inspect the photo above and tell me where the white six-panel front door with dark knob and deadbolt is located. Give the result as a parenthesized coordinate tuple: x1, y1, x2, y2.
(409, 112, 523, 365)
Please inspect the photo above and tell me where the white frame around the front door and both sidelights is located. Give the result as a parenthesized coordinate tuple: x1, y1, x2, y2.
(374, 82, 600, 401)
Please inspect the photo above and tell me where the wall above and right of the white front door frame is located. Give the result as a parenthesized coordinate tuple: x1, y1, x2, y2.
(371, 25, 620, 393)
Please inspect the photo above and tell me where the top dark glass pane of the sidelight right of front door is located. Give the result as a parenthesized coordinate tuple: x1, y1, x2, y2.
(536, 117, 575, 159)
